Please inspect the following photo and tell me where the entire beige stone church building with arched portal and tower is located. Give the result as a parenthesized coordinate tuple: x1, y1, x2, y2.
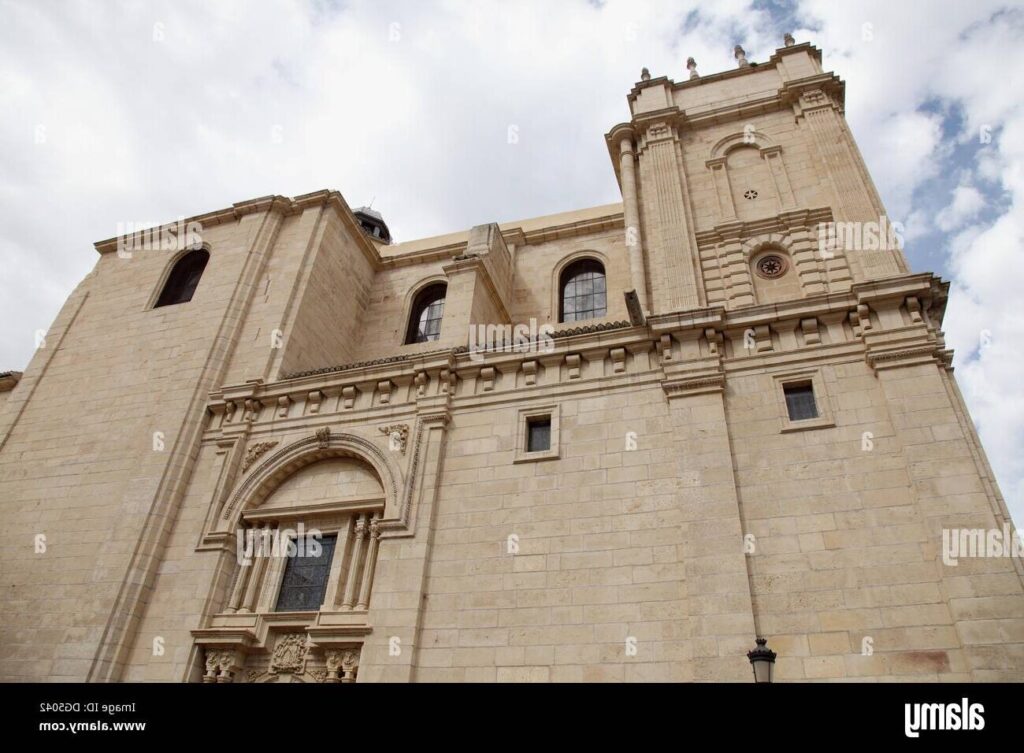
(0, 38, 1024, 682)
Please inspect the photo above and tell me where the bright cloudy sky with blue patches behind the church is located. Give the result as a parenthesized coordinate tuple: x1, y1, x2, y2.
(0, 0, 1024, 521)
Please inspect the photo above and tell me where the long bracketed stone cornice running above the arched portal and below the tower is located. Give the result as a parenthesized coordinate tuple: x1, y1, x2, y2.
(201, 275, 949, 440)
